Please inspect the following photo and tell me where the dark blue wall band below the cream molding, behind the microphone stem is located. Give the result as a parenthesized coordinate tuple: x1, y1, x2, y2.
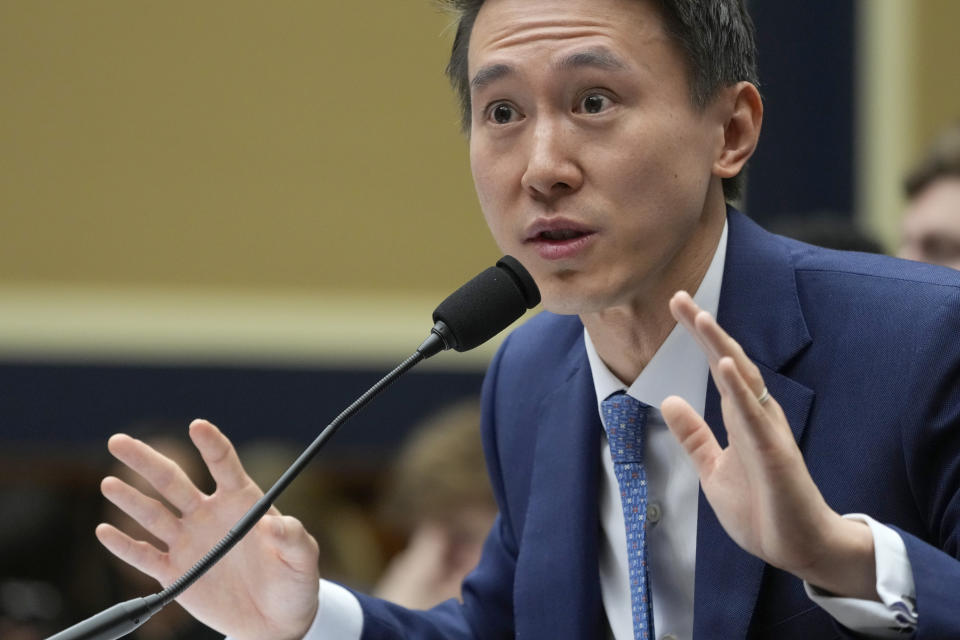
(0, 354, 482, 464)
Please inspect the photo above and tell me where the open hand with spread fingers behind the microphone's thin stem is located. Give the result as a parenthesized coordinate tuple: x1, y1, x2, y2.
(96, 420, 319, 640)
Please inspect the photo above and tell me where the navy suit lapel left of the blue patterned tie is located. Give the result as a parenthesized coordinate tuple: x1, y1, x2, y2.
(515, 337, 602, 640)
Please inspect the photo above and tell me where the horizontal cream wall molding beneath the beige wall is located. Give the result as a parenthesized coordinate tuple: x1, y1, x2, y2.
(0, 285, 524, 371)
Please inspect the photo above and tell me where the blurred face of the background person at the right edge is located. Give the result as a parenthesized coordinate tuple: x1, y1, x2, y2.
(897, 176, 960, 269)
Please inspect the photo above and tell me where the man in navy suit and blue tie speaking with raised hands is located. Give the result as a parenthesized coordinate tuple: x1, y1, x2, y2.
(97, 0, 960, 640)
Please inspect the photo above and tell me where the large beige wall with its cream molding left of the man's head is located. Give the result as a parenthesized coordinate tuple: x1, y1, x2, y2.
(0, 0, 510, 358)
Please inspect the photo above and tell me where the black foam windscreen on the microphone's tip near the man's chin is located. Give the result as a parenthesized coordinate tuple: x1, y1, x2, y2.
(433, 256, 540, 351)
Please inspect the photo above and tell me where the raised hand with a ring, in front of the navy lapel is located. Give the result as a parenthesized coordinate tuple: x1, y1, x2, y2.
(661, 291, 879, 600)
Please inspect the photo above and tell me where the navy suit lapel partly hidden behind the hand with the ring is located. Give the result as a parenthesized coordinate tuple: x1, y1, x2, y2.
(694, 210, 813, 638)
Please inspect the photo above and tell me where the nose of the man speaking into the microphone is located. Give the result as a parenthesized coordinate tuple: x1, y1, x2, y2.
(521, 119, 583, 201)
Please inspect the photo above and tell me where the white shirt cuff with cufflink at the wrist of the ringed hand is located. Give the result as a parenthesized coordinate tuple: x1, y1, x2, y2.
(803, 513, 917, 638)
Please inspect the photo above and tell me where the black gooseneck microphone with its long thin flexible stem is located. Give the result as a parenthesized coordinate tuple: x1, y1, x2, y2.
(47, 256, 540, 640)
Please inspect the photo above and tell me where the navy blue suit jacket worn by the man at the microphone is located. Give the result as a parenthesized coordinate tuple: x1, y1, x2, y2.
(359, 211, 960, 640)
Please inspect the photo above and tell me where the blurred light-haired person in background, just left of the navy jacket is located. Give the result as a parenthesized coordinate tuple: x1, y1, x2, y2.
(374, 398, 497, 609)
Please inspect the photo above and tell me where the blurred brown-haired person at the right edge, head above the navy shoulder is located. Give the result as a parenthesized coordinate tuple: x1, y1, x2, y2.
(897, 121, 960, 269)
